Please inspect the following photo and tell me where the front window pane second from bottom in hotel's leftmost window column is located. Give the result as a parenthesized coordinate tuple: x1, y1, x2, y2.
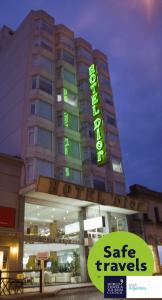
(37, 128, 52, 150)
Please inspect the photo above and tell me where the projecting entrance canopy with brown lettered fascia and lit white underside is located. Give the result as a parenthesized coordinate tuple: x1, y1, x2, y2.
(20, 176, 148, 214)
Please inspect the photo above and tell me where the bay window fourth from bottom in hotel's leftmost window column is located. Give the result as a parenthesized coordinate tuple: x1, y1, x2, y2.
(32, 75, 52, 95)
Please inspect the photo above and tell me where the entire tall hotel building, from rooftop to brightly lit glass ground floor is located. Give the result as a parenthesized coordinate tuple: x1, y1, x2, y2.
(0, 11, 149, 283)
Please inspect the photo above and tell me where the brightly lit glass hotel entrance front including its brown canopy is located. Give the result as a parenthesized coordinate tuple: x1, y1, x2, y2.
(18, 177, 150, 285)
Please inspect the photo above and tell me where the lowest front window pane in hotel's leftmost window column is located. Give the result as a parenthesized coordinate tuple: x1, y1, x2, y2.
(36, 159, 53, 177)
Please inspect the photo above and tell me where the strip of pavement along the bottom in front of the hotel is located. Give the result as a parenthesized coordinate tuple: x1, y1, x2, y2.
(0, 283, 95, 300)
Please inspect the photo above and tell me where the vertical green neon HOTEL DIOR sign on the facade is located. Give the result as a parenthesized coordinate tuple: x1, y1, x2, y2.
(89, 64, 106, 166)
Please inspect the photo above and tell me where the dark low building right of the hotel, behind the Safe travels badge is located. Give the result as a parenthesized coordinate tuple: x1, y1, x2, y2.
(127, 184, 162, 273)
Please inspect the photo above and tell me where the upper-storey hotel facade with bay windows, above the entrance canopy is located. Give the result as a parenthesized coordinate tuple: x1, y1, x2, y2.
(0, 11, 125, 194)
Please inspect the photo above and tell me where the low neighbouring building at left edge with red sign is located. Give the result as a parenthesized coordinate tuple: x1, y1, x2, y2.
(0, 154, 24, 271)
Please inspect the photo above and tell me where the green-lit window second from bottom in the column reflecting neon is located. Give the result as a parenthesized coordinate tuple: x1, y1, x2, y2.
(64, 137, 80, 159)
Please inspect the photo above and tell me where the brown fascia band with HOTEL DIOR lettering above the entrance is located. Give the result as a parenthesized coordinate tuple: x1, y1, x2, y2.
(35, 176, 148, 213)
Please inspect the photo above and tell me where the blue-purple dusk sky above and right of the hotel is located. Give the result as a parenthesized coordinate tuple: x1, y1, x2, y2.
(0, 0, 162, 192)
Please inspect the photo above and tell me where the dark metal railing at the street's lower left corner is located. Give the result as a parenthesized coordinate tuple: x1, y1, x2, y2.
(0, 270, 43, 296)
